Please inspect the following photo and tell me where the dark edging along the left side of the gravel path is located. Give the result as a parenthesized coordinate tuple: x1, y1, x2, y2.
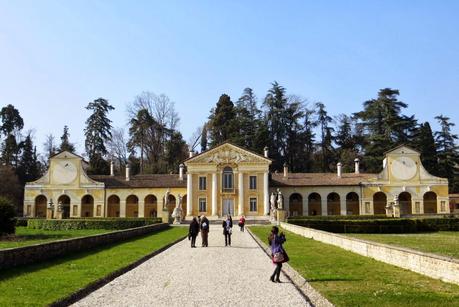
(49, 232, 187, 307)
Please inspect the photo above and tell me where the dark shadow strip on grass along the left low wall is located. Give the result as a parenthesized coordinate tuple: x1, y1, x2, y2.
(0, 228, 170, 282)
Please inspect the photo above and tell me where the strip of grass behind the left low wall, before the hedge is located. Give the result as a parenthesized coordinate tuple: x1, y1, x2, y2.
(0, 227, 110, 249)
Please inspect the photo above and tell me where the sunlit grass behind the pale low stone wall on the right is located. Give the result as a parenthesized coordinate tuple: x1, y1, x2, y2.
(346, 231, 459, 259)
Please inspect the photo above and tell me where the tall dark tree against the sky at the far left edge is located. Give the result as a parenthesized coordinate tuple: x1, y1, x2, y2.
(0, 104, 24, 167)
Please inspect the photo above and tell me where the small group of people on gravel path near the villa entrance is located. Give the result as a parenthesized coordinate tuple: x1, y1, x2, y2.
(188, 215, 245, 248)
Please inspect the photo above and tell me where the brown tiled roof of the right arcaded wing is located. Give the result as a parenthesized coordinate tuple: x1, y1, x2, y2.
(271, 173, 376, 187)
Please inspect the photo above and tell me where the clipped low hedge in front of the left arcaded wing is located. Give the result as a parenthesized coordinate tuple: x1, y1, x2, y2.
(27, 218, 160, 230)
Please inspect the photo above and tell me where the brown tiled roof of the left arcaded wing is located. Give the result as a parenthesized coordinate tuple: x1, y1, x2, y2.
(89, 174, 186, 189)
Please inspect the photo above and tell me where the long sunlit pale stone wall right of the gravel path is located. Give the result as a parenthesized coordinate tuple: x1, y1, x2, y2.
(281, 223, 459, 285)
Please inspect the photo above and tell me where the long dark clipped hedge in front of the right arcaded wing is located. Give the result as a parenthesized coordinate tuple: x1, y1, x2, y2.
(289, 218, 459, 233)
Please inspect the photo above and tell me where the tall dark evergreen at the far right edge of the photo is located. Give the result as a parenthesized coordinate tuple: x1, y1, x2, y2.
(435, 115, 459, 193)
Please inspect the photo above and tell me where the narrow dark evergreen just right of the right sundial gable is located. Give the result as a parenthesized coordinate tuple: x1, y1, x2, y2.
(413, 122, 438, 175)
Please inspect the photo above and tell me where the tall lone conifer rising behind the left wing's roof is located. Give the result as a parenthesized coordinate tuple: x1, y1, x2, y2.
(84, 98, 115, 174)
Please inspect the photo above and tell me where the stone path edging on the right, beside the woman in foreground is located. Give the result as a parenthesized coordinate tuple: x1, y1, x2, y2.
(246, 227, 334, 307)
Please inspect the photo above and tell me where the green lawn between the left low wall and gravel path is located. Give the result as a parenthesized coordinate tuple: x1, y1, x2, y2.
(0, 227, 188, 306)
